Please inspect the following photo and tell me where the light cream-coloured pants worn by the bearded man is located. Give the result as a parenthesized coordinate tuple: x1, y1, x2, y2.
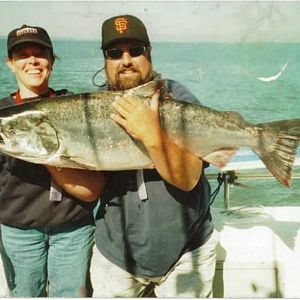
(91, 230, 219, 298)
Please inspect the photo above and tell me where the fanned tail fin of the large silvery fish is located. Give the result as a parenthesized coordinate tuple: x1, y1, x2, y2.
(255, 120, 300, 187)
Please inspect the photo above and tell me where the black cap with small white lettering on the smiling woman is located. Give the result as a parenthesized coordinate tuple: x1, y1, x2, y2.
(7, 25, 53, 53)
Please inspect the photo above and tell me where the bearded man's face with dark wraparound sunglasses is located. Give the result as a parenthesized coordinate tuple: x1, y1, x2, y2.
(105, 40, 152, 90)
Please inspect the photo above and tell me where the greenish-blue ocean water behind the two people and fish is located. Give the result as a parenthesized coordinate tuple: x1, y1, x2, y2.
(0, 39, 300, 207)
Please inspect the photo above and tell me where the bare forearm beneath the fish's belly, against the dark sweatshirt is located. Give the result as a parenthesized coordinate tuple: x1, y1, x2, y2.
(46, 166, 105, 202)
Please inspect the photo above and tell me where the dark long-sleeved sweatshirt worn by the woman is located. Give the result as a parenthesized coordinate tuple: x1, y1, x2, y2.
(0, 90, 94, 228)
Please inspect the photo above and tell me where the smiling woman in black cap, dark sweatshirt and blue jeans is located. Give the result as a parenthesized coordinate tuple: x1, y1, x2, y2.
(0, 25, 104, 297)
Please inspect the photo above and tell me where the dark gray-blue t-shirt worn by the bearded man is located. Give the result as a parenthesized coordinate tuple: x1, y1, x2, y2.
(95, 80, 213, 277)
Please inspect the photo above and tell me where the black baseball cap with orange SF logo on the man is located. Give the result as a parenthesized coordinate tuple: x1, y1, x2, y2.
(101, 15, 150, 49)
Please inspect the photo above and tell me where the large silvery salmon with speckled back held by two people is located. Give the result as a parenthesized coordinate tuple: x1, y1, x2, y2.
(0, 81, 300, 186)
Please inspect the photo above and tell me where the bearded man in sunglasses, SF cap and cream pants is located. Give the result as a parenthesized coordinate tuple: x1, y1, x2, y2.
(91, 15, 218, 297)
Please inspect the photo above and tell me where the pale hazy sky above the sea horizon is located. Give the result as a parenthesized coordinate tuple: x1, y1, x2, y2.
(0, 0, 300, 43)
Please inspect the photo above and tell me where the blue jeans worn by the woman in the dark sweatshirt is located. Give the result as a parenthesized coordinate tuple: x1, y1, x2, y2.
(0, 225, 95, 297)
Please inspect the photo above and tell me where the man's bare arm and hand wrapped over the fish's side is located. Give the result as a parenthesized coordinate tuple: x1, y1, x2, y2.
(112, 93, 202, 191)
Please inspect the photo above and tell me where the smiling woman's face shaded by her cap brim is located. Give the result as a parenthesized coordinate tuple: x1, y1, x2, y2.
(7, 43, 52, 94)
